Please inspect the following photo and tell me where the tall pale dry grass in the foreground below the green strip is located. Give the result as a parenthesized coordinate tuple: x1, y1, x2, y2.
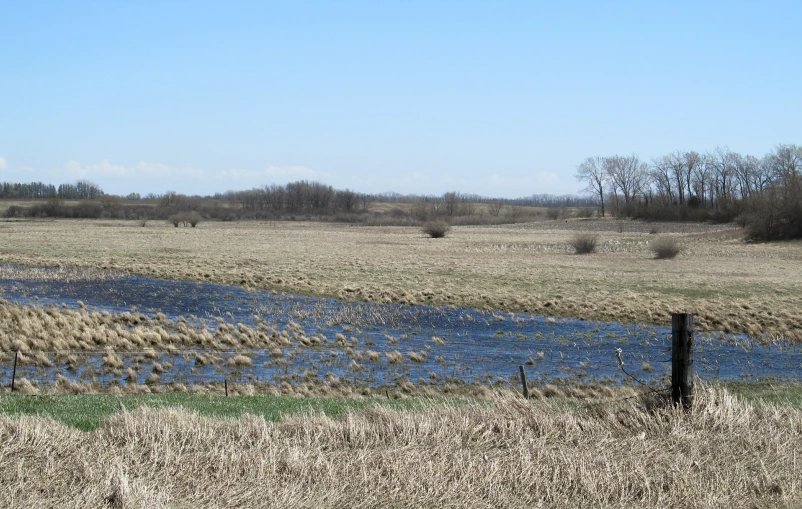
(0, 389, 802, 508)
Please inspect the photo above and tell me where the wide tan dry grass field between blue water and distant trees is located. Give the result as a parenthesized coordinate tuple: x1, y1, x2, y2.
(0, 216, 802, 337)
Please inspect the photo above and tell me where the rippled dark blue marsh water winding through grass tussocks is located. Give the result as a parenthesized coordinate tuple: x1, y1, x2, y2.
(0, 268, 802, 387)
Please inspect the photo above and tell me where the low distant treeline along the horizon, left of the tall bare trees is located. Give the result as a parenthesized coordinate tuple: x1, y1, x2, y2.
(0, 180, 596, 225)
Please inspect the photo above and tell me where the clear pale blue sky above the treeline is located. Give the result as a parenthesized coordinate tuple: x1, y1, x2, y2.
(0, 0, 802, 198)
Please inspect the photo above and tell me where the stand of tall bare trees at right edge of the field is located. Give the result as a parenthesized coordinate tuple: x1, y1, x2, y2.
(576, 145, 802, 239)
